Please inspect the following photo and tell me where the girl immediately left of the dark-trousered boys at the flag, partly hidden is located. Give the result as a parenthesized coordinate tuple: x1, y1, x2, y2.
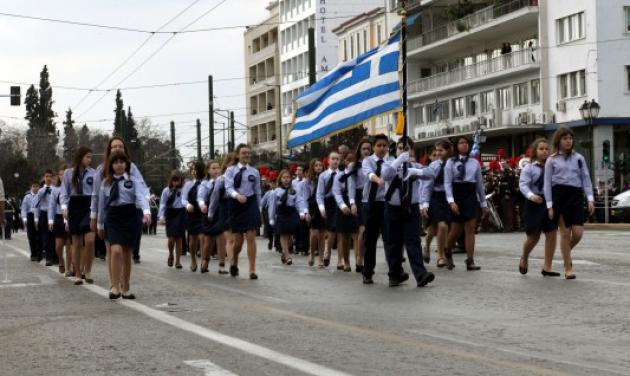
(349, 138, 372, 273)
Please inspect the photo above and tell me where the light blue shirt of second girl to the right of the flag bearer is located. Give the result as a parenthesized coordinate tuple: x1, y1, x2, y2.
(444, 156, 488, 208)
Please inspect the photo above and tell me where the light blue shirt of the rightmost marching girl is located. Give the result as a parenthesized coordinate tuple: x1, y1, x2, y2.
(545, 151, 595, 208)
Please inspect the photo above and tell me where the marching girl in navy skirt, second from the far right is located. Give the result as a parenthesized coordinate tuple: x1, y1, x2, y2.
(518, 138, 560, 277)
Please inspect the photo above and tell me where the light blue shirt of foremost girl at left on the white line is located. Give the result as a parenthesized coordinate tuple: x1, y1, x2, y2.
(97, 173, 151, 230)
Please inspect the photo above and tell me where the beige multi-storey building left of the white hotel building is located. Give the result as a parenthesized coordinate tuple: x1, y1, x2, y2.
(244, 1, 280, 152)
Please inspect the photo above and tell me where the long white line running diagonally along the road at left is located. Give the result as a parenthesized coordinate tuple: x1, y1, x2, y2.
(6, 244, 350, 376)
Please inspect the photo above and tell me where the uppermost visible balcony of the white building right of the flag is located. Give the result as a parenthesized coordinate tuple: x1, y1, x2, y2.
(407, 0, 538, 60)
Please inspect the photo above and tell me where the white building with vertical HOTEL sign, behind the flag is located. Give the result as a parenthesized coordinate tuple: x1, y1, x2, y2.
(279, 0, 383, 154)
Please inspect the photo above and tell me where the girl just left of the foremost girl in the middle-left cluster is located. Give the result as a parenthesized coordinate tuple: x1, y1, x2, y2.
(197, 161, 225, 273)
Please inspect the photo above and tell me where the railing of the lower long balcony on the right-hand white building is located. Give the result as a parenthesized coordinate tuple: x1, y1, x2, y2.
(409, 48, 540, 94)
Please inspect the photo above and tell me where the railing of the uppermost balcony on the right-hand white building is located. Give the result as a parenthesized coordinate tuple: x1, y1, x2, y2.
(408, 0, 538, 51)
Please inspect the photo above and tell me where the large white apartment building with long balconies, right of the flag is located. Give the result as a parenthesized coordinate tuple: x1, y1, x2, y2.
(398, 0, 630, 184)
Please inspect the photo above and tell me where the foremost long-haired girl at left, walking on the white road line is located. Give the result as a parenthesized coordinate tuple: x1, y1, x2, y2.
(97, 152, 151, 299)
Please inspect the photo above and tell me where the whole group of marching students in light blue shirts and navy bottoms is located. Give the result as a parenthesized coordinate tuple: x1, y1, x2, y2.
(16, 128, 594, 299)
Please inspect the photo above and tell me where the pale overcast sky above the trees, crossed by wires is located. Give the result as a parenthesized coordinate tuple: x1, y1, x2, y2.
(0, 0, 269, 157)
